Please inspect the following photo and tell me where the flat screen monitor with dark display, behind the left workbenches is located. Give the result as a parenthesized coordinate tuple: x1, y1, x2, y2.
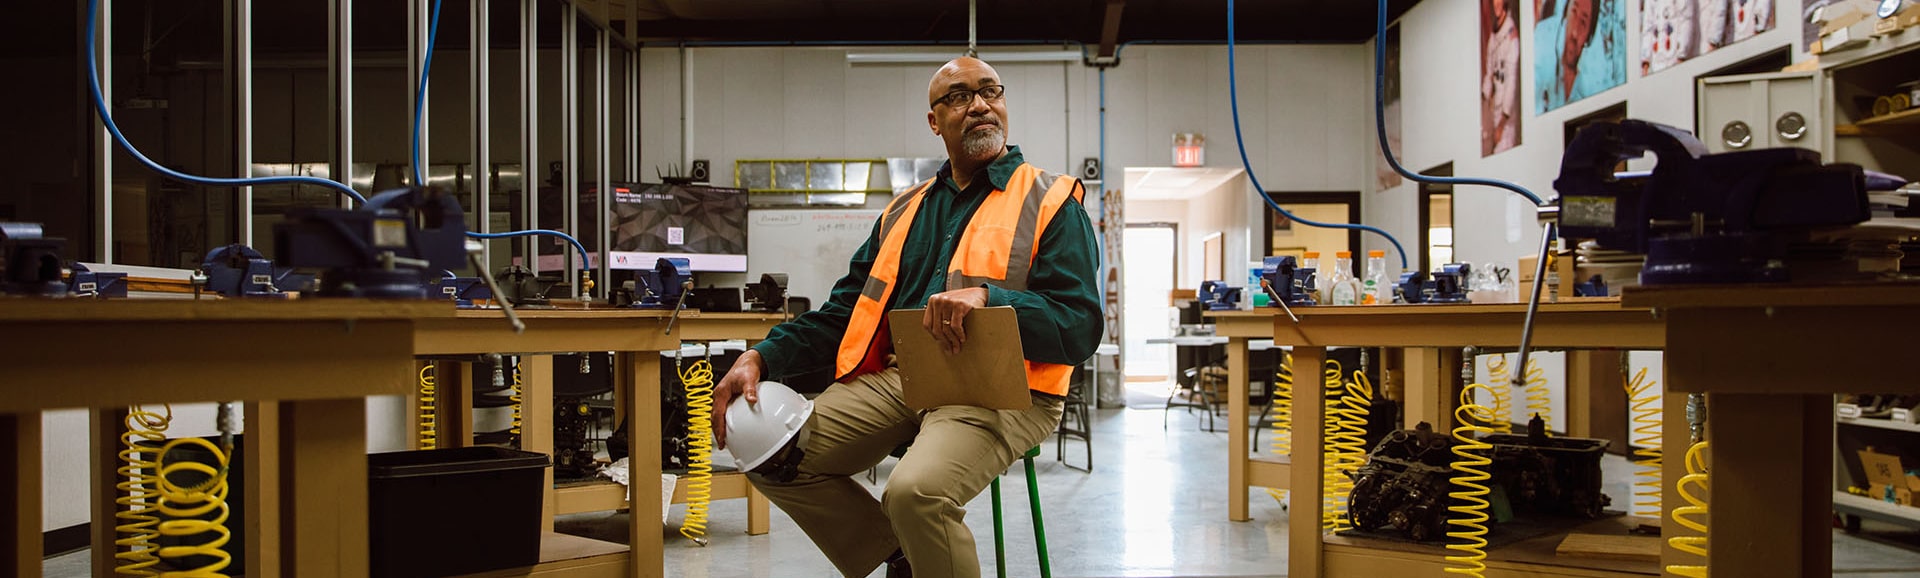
(607, 182, 747, 273)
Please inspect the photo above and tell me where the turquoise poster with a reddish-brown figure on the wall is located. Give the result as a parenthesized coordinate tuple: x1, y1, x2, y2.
(1534, 0, 1626, 113)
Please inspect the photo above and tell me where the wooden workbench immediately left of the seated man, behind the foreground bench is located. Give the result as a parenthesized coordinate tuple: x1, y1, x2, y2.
(407, 309, 783, 576)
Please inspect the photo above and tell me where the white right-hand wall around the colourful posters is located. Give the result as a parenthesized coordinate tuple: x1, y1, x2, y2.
(1363, 0, 1805, 265)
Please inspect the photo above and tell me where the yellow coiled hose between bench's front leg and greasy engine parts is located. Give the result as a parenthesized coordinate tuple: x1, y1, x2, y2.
(1321, 361, 1373, 532)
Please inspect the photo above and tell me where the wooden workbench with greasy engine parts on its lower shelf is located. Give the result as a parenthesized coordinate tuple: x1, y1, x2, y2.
(1208, 300, 1680, 578)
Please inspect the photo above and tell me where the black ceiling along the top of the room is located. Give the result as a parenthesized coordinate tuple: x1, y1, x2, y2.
(0, 0, 1419, 59)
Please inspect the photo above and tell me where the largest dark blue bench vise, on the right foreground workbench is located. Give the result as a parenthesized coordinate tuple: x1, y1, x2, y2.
(1553, 119, 1870, 284)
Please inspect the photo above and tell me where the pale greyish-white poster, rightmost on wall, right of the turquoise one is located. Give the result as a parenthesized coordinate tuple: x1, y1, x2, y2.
(1640, 0, 1774, 75)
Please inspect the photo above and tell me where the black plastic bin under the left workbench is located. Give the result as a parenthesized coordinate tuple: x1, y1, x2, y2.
(367, 447, 547, 578)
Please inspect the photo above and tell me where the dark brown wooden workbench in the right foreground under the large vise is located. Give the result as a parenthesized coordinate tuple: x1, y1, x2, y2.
(1622, 282, 1920, 576)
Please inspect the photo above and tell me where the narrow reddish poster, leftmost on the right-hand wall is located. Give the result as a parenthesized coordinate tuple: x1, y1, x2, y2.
(1480, 0, 1521, 157)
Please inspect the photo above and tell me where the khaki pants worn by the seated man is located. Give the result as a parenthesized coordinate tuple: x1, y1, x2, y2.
(747, 367, 1062, 578)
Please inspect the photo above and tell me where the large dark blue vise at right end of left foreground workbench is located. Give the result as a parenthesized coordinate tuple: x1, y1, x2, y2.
(273, 188, 467, 300)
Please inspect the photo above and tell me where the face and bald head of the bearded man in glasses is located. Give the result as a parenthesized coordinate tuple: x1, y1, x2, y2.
(927, 58, 1006, 163)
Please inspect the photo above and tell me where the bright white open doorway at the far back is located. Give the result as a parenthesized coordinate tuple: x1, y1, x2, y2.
(1121, 223, 1179, 382)
